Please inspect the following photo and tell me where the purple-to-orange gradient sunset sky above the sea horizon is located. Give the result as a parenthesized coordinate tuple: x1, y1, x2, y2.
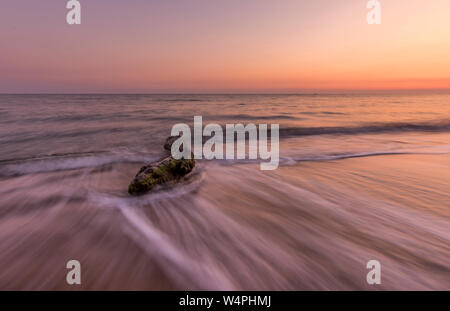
(0, 0, 450, 93)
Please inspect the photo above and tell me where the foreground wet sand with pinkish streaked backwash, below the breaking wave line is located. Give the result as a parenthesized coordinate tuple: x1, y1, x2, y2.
(0, 155, 450, 290)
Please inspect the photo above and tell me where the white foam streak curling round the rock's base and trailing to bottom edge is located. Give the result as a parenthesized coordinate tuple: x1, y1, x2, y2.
(89, 174, 235, 290)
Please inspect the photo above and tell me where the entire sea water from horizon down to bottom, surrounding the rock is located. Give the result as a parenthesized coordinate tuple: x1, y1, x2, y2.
(0, 92, 450, 290)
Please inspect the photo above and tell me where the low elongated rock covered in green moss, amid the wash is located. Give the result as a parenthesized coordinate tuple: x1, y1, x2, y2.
(128, 157, 195, 195)
